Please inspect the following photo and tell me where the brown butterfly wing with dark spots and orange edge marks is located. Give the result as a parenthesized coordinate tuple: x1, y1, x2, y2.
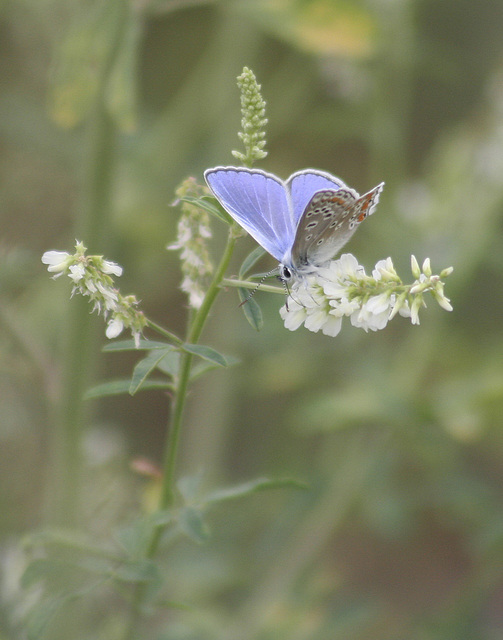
(291, 183, 384, 272)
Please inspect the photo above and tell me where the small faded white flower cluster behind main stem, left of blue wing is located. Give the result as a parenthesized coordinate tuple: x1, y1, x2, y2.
(167, 178, 213, 309)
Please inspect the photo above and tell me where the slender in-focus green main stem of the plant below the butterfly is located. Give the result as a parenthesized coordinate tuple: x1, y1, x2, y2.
(125, 228, 236, 640)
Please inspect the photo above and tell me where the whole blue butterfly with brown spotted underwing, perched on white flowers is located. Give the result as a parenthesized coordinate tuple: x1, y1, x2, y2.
(204, 167, 384, 281)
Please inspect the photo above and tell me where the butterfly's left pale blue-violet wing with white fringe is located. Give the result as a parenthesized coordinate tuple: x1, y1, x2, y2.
(204, 167, 297, 261)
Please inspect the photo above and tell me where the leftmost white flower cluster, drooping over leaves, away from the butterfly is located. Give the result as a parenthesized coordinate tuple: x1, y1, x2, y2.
(42, 242, 146, 347)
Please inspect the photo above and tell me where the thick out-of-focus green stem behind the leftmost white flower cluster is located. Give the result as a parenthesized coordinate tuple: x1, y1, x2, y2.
(47, 0, 129, 526)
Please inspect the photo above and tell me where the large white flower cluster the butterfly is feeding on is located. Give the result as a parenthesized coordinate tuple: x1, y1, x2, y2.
(280, 253, 452, 336)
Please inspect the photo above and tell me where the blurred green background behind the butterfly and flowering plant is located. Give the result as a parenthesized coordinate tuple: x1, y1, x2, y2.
(0, 0, 503, 640)
